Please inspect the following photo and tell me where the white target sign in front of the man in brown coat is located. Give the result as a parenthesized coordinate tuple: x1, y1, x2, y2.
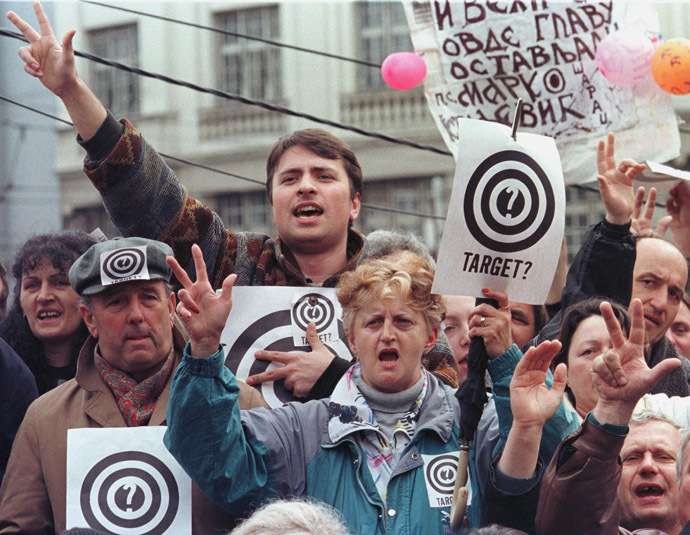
(66, 426, 192, 535)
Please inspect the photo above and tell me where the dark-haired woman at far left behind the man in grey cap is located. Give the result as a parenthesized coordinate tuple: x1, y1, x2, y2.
(0, 231, 95, 394)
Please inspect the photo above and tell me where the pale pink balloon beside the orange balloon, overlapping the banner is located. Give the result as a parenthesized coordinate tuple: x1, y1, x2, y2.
(596, 30, 654, 87)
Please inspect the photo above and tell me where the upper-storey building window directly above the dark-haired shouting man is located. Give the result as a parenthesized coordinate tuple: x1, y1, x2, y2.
(215, 6, 282, 100)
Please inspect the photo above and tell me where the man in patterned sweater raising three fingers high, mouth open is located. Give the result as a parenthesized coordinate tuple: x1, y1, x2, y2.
(8, 2, 457, 398)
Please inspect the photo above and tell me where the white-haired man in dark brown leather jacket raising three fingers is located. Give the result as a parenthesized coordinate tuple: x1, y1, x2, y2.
(536, 299, 681, 535)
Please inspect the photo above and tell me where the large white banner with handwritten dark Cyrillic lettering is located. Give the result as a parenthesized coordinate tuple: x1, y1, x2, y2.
(403, 0, 680, 184)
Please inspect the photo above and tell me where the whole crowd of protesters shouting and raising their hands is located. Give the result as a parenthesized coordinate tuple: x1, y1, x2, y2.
(6, 3, 690, 535)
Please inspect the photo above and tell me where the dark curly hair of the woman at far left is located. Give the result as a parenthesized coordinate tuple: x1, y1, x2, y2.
(0, 230, 96, 394)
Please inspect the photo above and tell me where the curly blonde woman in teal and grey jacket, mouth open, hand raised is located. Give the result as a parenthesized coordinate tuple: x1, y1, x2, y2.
(165, 246, 576, 535)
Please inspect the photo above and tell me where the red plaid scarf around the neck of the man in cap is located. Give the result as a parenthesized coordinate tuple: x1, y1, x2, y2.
(94, 346, 175, 427)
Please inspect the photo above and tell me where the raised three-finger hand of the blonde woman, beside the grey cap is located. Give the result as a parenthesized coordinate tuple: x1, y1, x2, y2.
(166, 244, 237, 357)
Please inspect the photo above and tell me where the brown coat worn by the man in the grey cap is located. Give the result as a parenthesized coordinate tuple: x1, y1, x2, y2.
(0, 332, 266, 535)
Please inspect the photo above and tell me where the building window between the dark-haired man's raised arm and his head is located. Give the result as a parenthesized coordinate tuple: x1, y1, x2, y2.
(218, 191, 275, 235)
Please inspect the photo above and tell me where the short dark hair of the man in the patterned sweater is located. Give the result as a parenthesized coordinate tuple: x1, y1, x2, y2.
(266, 128, 362, 204)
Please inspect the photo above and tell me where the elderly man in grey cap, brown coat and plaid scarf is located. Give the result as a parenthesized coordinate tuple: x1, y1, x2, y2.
(0, 238, 263, 535)
